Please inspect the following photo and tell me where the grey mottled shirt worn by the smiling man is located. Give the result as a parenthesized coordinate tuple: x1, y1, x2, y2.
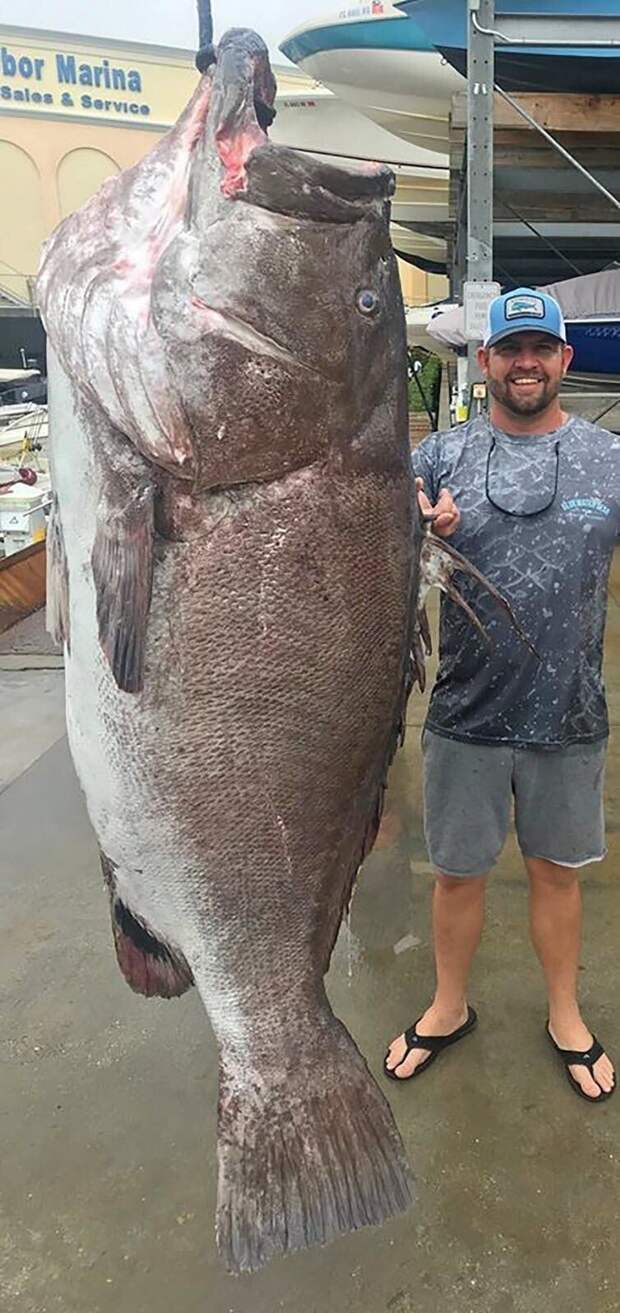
(414, 418, 620, 748)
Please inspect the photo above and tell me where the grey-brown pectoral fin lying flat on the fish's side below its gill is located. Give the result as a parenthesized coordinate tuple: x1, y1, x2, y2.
(92, 483, 154, 693)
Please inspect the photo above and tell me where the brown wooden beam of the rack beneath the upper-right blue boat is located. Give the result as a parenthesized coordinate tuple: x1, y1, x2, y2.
(452, 92, 620, 135)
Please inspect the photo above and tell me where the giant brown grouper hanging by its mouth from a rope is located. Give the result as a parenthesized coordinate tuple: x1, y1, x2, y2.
(39, 20, 528, 1272)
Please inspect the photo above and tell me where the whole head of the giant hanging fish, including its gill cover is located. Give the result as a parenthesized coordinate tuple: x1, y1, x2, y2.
(38, 29, 406, 490)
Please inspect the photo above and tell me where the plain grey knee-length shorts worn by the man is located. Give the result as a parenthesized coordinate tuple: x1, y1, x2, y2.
(422, 730, 607, 876)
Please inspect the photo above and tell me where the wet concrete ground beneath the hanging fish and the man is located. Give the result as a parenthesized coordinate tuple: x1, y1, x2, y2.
(0, 567, 620, 1313)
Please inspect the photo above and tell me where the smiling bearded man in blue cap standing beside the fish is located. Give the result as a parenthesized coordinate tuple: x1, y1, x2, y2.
(385, 288, 620, 1103)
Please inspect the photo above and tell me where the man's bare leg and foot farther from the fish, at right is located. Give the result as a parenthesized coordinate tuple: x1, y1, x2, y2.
(524, 857, 613, 1098)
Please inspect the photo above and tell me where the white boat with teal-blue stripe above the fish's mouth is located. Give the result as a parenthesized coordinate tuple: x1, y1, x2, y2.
(280, 0, 464, 155)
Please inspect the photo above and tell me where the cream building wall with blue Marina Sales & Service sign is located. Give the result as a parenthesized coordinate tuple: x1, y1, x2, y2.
(0, 26, 445, 315)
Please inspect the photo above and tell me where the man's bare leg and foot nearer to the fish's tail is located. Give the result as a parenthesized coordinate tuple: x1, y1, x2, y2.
(386, 876, 486, 1079)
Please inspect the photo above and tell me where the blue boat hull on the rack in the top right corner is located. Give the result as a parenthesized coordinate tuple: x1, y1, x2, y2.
(395, 0, 620, 96)
